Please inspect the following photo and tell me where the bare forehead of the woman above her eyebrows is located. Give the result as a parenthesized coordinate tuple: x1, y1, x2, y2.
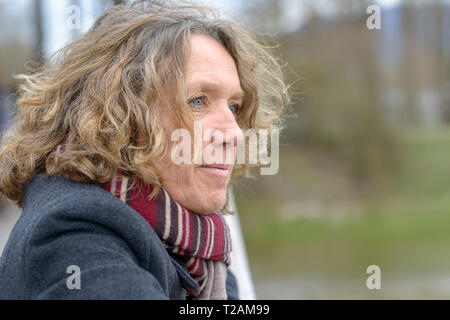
(186, 34, 240, 89)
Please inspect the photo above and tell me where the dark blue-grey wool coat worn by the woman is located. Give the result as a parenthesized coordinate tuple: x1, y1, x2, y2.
(0, 174, 238, 299)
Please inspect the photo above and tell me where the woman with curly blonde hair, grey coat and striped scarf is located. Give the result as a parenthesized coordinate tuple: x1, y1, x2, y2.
(0, 1, 288, 299)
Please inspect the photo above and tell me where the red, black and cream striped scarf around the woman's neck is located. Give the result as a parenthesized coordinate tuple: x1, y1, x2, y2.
(103, 169, 231, 299)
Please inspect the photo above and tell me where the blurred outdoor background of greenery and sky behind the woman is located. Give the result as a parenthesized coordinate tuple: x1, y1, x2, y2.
(0, 0, 450, 299)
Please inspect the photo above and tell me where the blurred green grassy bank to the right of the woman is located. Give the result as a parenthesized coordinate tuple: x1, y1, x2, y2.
(236, 124, 450, 276)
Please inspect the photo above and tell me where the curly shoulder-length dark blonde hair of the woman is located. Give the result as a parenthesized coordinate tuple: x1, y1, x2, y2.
(0, 0, 289, 207)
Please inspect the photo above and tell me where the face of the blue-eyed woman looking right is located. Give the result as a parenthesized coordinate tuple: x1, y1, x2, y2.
(154, 34, 243, 214)
